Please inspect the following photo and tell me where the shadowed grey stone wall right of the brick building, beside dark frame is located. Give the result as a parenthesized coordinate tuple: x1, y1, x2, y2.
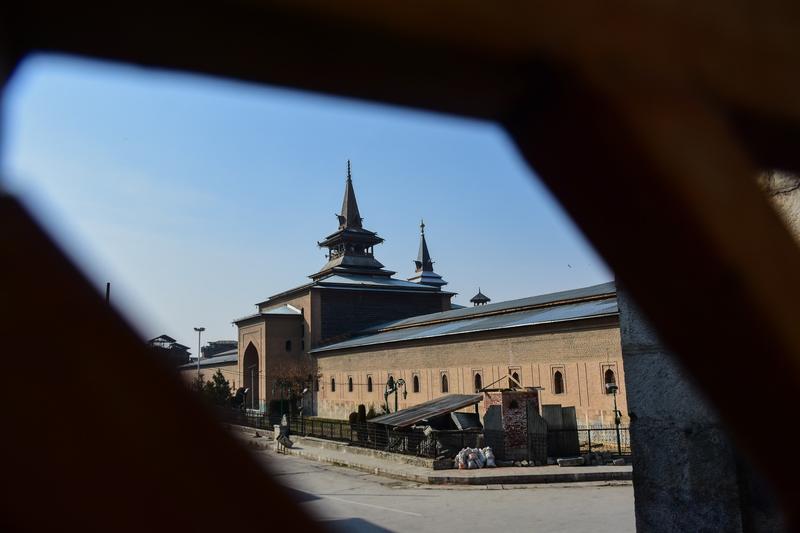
(617, 290, 742, 532)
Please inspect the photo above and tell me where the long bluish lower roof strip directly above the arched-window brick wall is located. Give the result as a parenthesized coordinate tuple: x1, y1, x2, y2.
(312, 296, 619, 353)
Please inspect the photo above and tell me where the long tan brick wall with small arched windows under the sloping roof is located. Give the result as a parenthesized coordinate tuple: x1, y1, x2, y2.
(316, 317, 627, 424)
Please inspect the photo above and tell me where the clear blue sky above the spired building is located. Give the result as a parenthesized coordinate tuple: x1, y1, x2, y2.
(2, 56, 612, 351)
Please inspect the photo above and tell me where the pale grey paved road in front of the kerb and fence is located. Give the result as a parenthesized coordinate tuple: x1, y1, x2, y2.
(259, 452, 635, 533)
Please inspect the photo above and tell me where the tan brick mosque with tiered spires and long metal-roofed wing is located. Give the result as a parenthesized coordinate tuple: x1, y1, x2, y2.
(188, 162, 627, 425)
